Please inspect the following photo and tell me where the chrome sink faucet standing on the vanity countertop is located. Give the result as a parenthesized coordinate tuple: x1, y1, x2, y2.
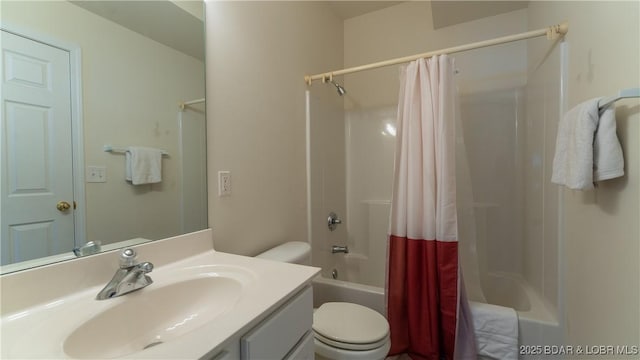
(96, 248, 153, 300)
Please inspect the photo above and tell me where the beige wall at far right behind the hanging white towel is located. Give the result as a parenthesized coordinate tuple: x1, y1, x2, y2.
(529, 1, 640, 348)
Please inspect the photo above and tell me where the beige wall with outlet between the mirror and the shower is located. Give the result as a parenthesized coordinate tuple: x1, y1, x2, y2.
(206, 1, 343, 255)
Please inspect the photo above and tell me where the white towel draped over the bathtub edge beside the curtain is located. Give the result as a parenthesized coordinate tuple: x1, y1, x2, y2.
(469, 301, 518, 360)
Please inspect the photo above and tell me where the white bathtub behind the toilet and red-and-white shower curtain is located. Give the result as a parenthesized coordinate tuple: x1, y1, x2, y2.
(313, 273, 562, 360)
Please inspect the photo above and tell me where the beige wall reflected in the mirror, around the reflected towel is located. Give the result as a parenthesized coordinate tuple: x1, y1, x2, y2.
(2, 1, 204, 243)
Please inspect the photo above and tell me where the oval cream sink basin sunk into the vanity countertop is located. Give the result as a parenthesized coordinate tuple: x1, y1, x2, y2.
(63, 268, 248, 359)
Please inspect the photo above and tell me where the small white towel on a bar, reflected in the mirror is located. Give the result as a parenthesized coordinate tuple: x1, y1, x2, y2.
(125, 146, 162, 185)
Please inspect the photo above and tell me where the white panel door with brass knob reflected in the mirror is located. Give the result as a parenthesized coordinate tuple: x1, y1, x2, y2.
(0, 30, 74, 265)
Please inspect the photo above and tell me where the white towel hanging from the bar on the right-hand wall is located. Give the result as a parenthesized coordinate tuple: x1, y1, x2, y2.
(551, 98, 624, 190)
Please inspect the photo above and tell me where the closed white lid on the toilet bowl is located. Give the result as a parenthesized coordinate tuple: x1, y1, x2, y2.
(313, 302, 389, 345)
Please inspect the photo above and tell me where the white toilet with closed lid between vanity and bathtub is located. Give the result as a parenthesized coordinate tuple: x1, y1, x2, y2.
(256, 241, 391, 360)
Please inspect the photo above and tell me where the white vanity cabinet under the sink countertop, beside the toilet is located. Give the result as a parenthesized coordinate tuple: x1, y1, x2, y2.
(205, 286, 314, 360)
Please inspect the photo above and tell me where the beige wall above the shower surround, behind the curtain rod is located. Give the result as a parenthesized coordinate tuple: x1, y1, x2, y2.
(344, 1, 527, 108)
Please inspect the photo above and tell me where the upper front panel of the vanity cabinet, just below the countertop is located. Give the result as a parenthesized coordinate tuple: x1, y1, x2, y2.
(240, 287, 313, 360)
